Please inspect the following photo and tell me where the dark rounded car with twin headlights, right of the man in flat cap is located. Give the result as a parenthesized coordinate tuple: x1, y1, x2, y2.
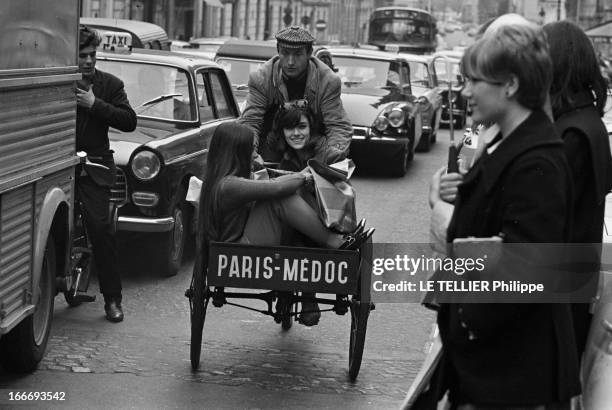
(329, 48, 427, 176)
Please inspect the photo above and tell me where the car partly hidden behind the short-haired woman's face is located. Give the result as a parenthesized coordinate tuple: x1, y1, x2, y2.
(434, 51, 470, 129)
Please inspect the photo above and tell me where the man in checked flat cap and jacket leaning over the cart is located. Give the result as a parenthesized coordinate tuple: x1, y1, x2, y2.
(239, 26, 353, 161)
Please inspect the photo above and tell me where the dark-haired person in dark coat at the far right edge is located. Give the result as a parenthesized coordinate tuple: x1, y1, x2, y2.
(544, 21, 612, 355)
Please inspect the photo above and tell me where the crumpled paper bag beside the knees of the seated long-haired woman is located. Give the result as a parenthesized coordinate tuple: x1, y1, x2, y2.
(308, 159, 357, 233)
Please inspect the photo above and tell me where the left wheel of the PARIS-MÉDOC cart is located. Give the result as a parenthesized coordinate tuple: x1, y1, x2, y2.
(189, 271, 210, 370)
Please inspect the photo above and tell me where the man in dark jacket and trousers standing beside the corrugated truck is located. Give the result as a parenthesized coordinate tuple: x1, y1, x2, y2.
(76, 26, 136, 322)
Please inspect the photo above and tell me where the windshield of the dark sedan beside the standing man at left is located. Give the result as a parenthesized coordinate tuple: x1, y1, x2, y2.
(96, 60, 197, 121)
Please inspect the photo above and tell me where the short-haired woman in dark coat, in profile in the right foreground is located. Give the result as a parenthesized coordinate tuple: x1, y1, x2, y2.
(436, 25, 580, 409)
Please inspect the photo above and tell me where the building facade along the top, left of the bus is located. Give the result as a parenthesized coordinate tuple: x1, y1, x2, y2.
(81, 0, 392, 44)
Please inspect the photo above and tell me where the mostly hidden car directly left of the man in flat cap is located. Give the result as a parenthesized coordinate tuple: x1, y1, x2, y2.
(215, 40, 278, 109)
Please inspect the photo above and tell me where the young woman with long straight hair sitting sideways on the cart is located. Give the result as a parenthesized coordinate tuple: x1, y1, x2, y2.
(200, 122, 365, 249)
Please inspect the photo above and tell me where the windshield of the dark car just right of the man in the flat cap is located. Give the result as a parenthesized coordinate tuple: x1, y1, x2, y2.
(334, 56, 399, 88)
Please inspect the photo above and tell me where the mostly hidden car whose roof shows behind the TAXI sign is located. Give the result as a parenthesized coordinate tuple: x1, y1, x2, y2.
(80, 17, 170, 50)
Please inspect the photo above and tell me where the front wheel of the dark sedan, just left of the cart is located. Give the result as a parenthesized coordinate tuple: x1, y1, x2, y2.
(152, 202, 189, 277)
